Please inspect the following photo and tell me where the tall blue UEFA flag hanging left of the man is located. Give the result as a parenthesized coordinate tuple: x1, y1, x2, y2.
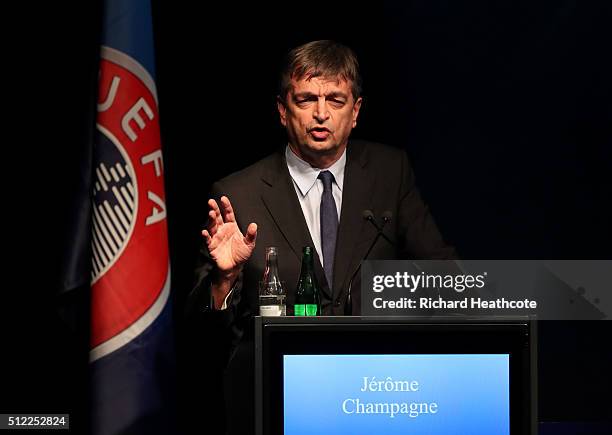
(89, 0, 175, 435)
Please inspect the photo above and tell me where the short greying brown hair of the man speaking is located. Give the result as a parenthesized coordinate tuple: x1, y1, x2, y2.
(279, 40, 361, 101)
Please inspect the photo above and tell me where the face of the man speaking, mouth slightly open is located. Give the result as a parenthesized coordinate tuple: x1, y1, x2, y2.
(278, 77, 361, 164)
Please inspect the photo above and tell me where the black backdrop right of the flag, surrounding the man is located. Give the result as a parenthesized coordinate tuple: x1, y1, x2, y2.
(156, 0, 612, 426)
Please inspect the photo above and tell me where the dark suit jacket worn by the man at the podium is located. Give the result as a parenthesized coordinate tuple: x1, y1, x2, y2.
(188, 141, 455, 435)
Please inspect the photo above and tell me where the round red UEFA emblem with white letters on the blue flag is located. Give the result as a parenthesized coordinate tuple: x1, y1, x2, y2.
(90, 47, 170, 361)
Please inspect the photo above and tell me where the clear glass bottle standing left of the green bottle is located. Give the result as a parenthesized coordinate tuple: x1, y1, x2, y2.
(259, 246, 287, 316)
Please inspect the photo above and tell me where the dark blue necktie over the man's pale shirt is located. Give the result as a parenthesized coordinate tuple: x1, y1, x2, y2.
(319, 171, 338, 289)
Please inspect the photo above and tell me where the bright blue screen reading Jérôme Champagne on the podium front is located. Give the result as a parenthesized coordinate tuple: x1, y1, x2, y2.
(284, 354, 510, 435)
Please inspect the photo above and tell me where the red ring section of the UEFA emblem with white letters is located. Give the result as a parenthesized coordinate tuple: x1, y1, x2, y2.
(91, 59, 169, 348)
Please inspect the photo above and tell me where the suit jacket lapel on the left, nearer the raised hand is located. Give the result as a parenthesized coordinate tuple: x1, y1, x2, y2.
(261, 150, 332, 299)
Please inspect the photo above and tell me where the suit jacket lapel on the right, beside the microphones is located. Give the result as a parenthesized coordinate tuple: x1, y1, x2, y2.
(333, 142, 375, 298)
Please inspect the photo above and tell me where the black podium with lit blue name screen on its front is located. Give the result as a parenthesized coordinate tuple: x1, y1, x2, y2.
(255, 317, 537, 435)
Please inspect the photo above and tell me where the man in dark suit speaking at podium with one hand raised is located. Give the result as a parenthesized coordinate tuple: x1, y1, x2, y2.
(184, 41, 455, 434)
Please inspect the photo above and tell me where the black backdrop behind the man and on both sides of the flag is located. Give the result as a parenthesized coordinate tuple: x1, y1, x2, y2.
(2, 0, 612, 425)
